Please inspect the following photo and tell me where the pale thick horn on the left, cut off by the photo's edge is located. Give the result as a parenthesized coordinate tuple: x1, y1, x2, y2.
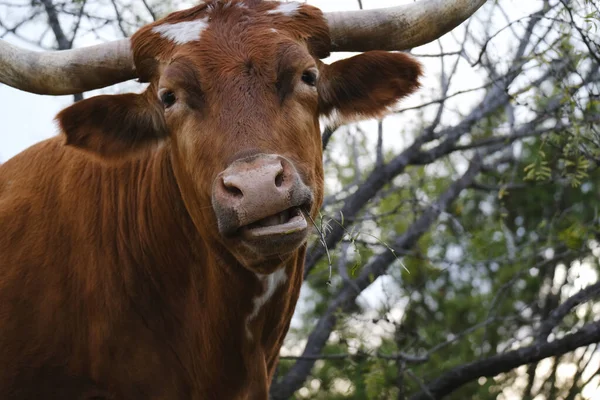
(0, 39, 137, 95)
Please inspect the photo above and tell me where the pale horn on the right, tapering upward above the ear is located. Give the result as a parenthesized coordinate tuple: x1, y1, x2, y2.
(325, 0, 487, 51)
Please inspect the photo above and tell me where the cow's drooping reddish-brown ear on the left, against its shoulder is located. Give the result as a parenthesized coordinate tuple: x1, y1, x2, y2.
(56, 93, 167, 159)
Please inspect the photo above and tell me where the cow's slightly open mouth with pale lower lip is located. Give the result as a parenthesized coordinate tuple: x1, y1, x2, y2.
(239, 207, 308, 240)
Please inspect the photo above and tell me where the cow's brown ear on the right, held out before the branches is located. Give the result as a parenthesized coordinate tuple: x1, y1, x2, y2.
(318, 51, 421, 124)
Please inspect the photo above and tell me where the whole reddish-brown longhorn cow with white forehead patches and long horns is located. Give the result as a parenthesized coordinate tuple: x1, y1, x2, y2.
(0, 0, 485, 400)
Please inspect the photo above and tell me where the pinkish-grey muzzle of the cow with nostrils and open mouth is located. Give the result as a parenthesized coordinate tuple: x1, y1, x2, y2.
(212, 154, 313, 252)
